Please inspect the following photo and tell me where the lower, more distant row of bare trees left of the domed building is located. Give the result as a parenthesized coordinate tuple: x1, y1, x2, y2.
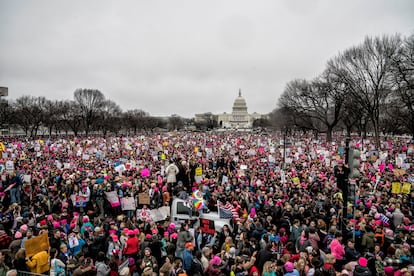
(0, 89, 186, 137)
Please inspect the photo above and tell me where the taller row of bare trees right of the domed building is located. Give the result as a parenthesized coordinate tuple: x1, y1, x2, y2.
(271, 31, 414, 145)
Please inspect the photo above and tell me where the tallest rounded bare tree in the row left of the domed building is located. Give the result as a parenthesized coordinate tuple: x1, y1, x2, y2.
(74, 89, 105, 136)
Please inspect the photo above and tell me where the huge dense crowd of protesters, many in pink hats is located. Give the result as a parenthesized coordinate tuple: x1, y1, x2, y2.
(0, 132, 414, 276)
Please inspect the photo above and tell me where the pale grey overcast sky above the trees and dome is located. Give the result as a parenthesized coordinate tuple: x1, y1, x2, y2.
(0, 0, 414, 118)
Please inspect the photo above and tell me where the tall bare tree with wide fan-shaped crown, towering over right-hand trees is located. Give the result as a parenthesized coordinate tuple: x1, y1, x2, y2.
(328, 35, 401, 146)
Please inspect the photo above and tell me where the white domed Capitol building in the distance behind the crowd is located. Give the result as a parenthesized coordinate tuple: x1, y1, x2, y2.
(194, 89, 267, 129)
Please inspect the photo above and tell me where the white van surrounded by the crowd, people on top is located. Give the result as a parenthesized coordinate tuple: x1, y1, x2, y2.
(171, 198, 233, 232)
